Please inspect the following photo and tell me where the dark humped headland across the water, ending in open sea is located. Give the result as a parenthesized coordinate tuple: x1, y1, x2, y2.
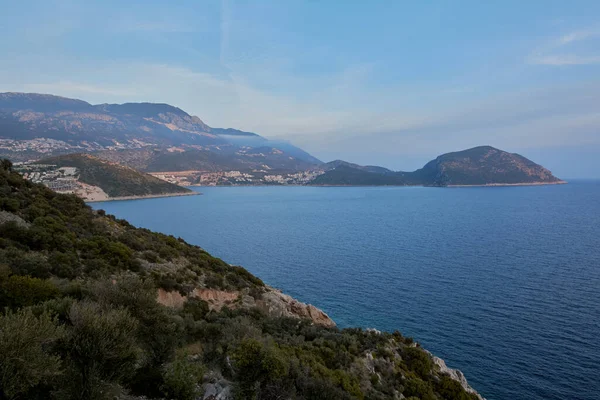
(311, 146, 564, 186)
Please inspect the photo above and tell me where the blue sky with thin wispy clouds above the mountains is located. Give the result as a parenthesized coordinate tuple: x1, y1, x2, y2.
(0, 0, 600, 178)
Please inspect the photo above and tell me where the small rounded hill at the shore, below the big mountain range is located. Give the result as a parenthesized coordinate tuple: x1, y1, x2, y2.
(29, 154, 194, 200)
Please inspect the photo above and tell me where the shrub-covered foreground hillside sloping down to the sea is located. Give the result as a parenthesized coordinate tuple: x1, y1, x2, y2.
(0, 160, 481, 400)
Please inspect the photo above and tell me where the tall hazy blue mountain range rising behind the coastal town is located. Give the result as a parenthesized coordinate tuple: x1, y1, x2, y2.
(0, 93, 321, 169)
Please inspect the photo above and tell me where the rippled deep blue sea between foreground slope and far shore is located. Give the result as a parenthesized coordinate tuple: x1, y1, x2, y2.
(93, 182, 600, 400)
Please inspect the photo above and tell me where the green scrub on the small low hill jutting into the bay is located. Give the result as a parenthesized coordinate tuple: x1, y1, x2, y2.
(39, 154, 191, 197)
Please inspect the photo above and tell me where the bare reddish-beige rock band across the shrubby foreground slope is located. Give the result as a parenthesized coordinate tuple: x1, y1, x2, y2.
(157, 286, 335, 327)
